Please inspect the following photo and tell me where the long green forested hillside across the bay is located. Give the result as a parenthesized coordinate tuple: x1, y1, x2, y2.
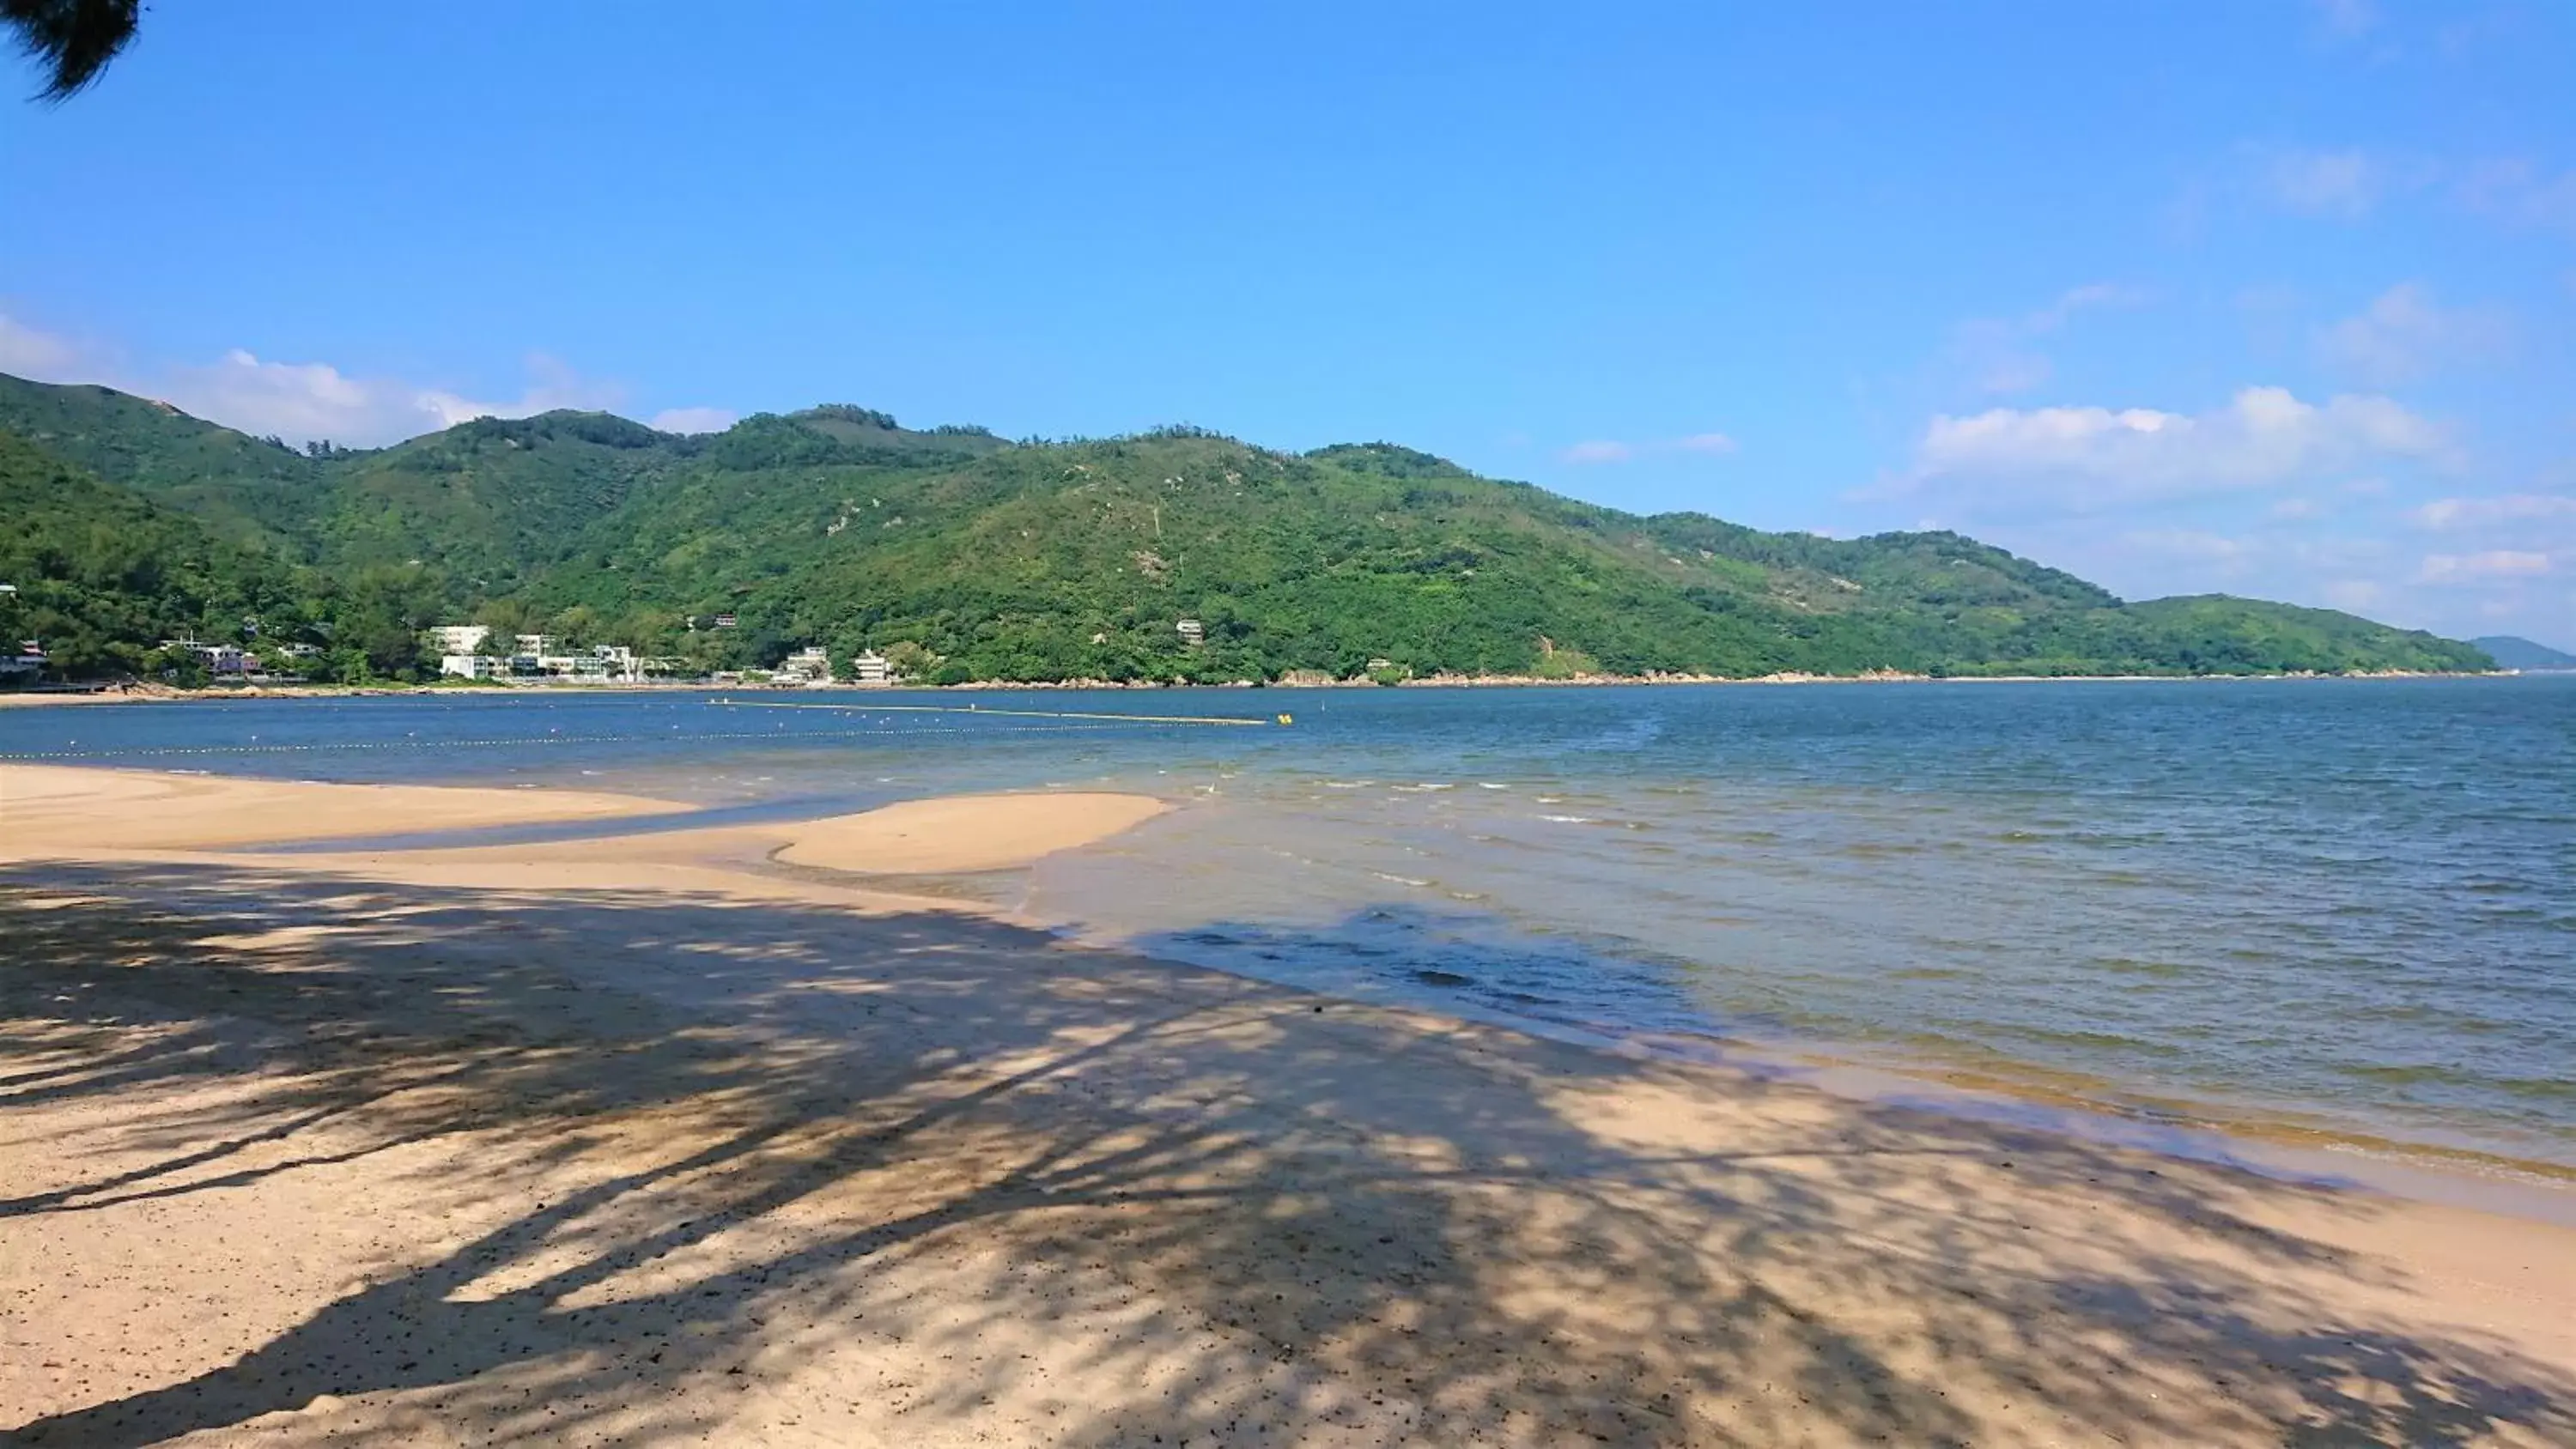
(0, 376, 2494, 685)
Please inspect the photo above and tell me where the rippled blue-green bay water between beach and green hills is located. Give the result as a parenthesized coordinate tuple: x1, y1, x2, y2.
(0, 680, 2576, 1171)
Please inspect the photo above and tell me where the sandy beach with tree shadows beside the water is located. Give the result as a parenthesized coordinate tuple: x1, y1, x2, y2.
(0, 764, 2576, 1446)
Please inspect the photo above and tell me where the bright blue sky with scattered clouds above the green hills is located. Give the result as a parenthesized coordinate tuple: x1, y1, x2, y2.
(0, 0, 2576, 646)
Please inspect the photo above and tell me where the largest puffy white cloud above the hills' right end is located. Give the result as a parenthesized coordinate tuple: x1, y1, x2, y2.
(1891, 386, 2450, 510)
